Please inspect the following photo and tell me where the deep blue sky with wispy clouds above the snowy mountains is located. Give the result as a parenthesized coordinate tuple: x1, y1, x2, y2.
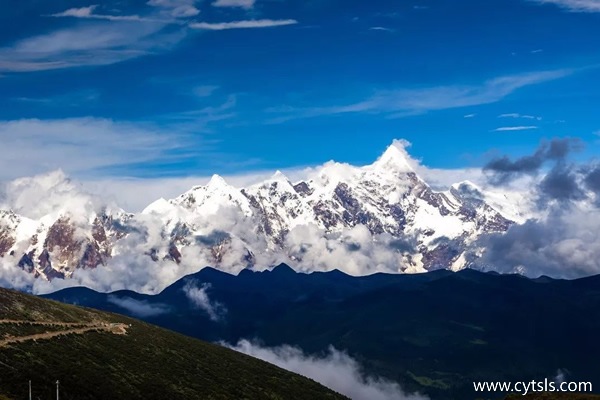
(0, 0, 600, 178)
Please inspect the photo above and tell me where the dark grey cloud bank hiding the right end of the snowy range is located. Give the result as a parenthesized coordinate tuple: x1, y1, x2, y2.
(475, 138, 600, 278)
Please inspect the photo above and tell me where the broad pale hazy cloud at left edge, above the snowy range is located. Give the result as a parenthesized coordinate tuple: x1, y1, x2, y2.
(0, 118, 201, 179)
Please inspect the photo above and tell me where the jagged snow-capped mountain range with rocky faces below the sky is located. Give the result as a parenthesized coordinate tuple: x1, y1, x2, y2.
(0, 142, 527, 280)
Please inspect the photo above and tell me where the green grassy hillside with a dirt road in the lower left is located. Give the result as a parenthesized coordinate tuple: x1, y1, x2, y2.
(0, 289, 344, 400)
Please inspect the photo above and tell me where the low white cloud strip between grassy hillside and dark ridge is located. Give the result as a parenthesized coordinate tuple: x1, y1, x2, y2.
(228, 340, 427, 400)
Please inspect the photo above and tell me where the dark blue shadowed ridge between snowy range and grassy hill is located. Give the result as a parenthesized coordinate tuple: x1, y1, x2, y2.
(51, 265, 600, 400)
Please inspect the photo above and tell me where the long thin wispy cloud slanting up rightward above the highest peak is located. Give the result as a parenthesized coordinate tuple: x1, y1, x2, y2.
(267, 69, 574, 123)
